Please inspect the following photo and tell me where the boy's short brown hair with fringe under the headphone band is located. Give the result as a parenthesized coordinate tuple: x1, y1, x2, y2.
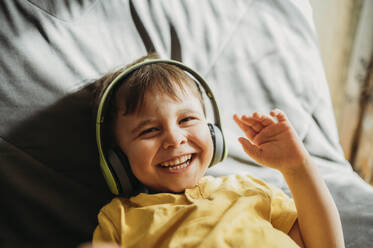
(95, 53, 205, 145)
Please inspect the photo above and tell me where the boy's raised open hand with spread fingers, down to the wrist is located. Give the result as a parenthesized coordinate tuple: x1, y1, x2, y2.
(233, 109, 309, 173)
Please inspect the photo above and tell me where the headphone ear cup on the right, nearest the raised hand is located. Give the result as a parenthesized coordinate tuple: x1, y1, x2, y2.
(207, 123, 226, 167)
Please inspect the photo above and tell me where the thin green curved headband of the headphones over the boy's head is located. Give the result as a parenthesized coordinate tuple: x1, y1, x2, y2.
(96, 59, 227, 195)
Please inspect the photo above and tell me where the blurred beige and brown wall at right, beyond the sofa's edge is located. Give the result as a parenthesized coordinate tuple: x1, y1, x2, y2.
(310, 0, 373, 185)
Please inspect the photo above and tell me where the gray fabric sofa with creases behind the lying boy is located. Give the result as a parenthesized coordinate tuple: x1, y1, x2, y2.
(0, 0, 373, 248)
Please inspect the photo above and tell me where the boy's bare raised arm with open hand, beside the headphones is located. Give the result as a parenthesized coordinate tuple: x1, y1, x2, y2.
(234, 110, 344, 248)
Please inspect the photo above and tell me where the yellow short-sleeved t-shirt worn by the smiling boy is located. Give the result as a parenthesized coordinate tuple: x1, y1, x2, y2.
(93, 175, 298, 248)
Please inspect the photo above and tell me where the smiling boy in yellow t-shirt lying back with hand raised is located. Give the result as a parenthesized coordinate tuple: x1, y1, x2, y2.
(93, 53, 344, 248)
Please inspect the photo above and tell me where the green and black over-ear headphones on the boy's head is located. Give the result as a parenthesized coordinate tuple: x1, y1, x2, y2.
(96, 59, 227, 197)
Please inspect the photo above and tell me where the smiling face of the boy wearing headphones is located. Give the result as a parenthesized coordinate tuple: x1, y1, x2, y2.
(115, 84, 213, 192)
